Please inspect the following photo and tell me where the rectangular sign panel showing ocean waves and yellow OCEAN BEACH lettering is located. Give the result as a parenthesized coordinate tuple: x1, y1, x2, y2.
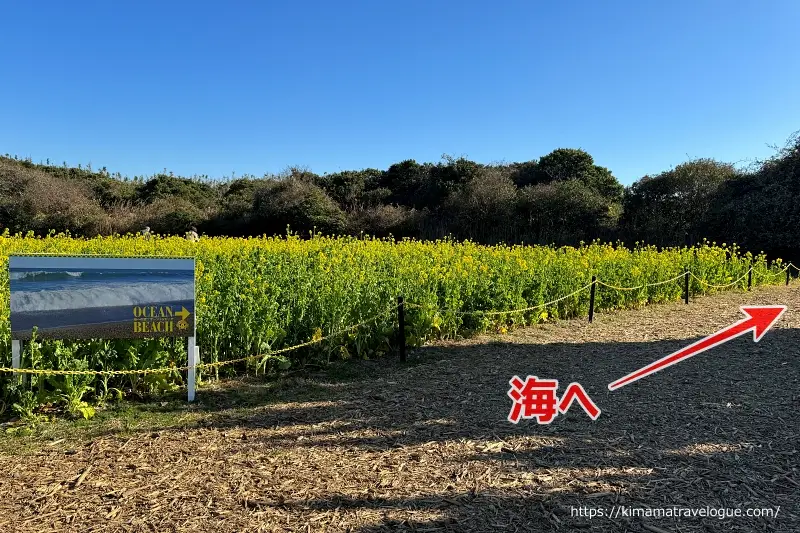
(9, 256, 195, 339)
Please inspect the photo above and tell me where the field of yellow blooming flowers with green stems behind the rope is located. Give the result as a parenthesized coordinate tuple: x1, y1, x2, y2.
(0, 234, 783, 416)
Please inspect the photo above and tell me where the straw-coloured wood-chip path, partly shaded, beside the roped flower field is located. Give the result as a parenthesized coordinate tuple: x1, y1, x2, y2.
(0, 285, 800, 533)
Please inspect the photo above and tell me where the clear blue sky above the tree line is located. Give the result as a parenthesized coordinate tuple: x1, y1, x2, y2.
(0, 0, 800, 184)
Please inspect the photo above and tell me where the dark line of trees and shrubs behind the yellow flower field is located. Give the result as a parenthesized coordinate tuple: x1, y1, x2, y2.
(0, 134, 800, 258)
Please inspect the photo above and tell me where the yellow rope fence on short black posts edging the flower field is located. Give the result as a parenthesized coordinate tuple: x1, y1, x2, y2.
(0, 263, 800, 376)
